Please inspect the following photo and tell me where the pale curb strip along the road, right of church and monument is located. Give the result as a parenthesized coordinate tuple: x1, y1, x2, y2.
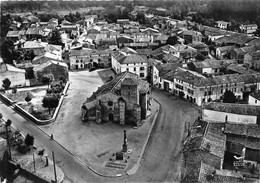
(126, 99, 161, 175)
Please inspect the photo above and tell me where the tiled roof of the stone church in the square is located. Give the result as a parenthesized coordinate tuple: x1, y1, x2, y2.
(86, 72, 149, 103)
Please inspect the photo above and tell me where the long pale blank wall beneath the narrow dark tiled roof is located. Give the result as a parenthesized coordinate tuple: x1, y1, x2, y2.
(202, 109, 257, 124)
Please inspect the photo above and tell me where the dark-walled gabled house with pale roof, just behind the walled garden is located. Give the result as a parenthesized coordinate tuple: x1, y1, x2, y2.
(33, 60, 69, 82)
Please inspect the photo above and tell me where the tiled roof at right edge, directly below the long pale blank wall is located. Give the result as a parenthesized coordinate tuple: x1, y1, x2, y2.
(224, 123, 260, 139)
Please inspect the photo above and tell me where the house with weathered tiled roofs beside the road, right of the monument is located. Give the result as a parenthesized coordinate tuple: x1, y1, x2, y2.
(182, 120, 228, 183)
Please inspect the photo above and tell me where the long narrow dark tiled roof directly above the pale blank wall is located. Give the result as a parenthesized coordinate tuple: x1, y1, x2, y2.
(204, 102, 260, 116)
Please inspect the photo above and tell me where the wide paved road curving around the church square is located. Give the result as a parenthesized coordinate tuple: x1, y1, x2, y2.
(0, 87, 197, 182)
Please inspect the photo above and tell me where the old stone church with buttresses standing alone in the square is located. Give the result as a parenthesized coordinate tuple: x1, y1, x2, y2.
(81, 72, 150, 126)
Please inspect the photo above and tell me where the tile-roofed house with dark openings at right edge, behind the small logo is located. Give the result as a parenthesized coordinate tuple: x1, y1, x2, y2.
(224, 121, 260, 171)
